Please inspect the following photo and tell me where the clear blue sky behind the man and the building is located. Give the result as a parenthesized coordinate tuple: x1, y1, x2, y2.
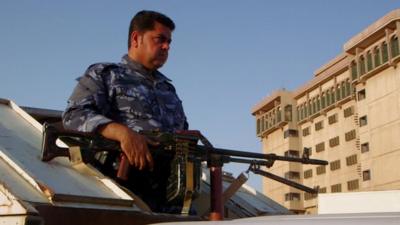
(0, 0, 400, 190)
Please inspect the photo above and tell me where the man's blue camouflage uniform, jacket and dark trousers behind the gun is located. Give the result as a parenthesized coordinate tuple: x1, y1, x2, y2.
(62, 55, 188, 212)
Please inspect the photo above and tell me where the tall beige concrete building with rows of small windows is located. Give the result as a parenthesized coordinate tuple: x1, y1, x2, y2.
(252, 9, 400, 213)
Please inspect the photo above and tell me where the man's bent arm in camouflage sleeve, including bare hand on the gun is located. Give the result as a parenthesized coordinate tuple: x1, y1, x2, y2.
(62, 65, 153, 169)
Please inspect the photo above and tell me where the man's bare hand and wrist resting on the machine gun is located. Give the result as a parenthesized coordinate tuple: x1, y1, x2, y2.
(99, 123, 157, 170)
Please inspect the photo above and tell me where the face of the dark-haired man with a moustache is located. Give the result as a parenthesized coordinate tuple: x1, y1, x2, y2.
(133, 22, 172, 70)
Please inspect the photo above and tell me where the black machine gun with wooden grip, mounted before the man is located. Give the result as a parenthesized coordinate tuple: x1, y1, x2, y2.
(42, 123, 328, 220)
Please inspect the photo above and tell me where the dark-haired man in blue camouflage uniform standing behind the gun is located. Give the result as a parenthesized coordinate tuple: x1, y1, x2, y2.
(63, 11, 188, 211)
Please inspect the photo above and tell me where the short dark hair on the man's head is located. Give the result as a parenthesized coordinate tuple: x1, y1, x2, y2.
(128, 10, 175, 49)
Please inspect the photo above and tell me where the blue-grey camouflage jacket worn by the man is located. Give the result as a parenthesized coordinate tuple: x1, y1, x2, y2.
(62, 55, 188, 132)
